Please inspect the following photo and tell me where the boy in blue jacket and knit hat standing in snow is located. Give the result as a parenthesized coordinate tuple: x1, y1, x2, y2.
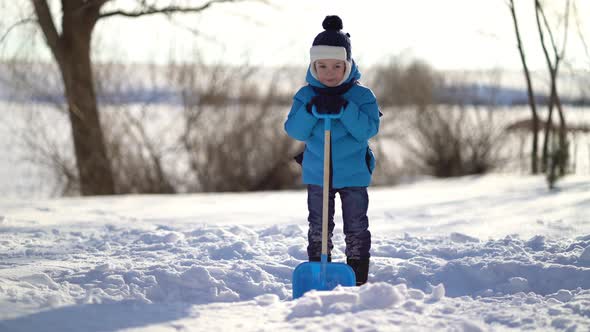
(285, 16, 380, 286)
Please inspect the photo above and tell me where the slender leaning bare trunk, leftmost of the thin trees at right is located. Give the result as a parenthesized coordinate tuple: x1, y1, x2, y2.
(507, 0, 539, 174)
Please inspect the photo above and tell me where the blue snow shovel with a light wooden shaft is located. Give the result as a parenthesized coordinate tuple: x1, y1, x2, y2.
(293, 105, 356, 299)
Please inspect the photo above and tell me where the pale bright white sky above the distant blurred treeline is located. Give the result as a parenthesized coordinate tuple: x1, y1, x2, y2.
(4, 0, 590, 70)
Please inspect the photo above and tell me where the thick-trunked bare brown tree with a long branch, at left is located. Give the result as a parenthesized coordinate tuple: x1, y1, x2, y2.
(1, 0, 254, 195)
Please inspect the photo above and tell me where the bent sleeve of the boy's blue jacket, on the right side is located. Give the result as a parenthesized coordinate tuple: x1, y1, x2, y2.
(340, 90, 380, 142)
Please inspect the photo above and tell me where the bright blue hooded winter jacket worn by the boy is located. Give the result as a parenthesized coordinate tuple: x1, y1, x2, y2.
(285, 61, 379, 188)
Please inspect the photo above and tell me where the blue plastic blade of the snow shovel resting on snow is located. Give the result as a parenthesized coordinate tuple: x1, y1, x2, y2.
(293, 262, 356, 299)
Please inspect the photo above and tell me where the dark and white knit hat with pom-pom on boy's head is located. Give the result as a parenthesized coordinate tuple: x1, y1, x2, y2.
(309, 15, 352, 84)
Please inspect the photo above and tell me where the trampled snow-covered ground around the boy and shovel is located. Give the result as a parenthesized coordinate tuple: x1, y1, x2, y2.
(0, 175, 590, 332)
